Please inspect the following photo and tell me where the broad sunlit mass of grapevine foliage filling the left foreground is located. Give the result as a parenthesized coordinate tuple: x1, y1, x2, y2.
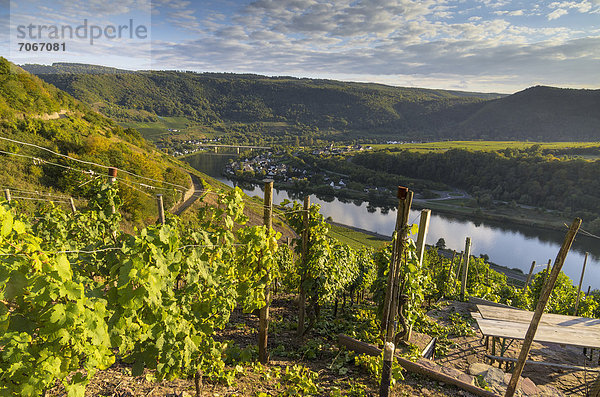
(0, 183, 279, 396)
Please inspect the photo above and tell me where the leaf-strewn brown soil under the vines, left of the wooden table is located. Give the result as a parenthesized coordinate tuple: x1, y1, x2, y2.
(46, 294, 482, 397)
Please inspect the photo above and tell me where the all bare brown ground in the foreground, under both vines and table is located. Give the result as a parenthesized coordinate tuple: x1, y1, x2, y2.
(46, 294, 595, 397)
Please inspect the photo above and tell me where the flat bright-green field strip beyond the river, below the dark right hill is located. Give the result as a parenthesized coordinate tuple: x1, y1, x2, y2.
(371, 141, 599, 152)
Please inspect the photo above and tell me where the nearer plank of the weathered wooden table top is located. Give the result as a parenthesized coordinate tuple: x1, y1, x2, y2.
(471, 313, 600, 348)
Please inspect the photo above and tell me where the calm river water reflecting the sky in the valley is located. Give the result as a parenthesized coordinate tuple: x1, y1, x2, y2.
(185, 153, 600, 291)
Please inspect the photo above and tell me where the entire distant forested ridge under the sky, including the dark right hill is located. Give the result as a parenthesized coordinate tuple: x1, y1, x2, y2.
(23, 63, 600, 140)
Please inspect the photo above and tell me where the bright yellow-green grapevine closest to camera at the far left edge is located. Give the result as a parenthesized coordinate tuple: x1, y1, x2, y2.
(0, 204, 114, 396)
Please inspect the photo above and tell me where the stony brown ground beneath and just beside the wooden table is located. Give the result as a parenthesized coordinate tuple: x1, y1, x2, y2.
(428, 301, 599, 396)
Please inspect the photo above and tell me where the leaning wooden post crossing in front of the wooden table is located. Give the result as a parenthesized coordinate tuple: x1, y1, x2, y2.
(504, 218, 581, 397)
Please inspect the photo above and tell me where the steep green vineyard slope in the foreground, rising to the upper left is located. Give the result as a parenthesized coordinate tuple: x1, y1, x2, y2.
(0, 58, 600, 397)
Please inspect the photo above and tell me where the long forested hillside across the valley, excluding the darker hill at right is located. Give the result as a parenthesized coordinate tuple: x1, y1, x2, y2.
(24, 64, 501, 140)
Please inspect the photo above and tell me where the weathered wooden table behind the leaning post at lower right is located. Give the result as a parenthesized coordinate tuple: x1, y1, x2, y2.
(471, 304, 600, 366)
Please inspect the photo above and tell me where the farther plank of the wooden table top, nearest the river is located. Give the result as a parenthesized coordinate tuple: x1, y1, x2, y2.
(477, 305, 600, 332)
